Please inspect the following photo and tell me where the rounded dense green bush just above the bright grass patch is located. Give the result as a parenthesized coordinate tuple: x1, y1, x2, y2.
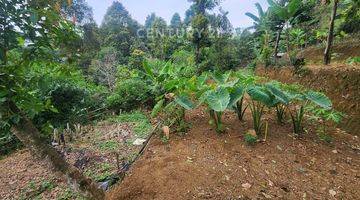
(107, 78, 154, 111)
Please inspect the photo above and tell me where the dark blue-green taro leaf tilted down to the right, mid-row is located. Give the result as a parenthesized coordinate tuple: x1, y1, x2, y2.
(247, 86, 276, 107)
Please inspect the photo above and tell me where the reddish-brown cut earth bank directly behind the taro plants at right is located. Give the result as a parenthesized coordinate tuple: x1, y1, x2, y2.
(256, 64, 360, 135)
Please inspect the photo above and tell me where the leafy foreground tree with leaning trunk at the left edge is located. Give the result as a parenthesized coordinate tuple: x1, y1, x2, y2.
(0, 0, 104, 199)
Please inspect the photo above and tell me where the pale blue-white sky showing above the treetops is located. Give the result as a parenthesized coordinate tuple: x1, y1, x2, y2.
(87, 0, 268, 28)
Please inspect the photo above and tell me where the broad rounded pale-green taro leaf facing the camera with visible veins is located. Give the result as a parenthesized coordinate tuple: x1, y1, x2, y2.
(206, 88, 230, 112)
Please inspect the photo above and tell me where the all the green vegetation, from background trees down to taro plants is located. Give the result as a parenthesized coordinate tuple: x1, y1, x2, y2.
(0, 0, 360, 198)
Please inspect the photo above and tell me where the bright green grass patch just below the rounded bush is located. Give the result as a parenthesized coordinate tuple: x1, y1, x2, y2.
(108, 111, 152, 138)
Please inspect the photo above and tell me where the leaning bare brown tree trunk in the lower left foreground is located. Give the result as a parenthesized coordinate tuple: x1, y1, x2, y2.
(8, 101, 105, 200)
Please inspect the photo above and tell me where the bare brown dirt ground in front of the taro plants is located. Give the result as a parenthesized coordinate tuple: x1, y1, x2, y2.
(107, 110, 360, 200)
